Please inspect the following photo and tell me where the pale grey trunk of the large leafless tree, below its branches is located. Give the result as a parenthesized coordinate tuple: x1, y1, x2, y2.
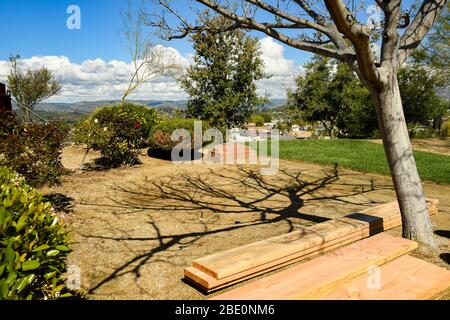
(371, 71, 437, 250)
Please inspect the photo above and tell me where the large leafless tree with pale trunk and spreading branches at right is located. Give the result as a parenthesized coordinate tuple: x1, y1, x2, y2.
(145, 0, 446, 249)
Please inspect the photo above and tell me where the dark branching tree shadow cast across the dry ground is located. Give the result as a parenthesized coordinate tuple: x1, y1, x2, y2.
(81, 167, 391, 294)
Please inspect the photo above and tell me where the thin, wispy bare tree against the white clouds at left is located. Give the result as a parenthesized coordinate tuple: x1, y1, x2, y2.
(121, 1, 181, 104)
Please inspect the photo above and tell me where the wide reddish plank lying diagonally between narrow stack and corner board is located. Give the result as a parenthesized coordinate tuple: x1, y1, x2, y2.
(213, 234, 417, 300)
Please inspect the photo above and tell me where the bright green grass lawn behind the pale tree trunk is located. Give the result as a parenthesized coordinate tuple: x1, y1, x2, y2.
(253, 139, 450, 184)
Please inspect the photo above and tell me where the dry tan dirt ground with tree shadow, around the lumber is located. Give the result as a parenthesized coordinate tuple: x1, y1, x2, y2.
(43, 147, 450, 299)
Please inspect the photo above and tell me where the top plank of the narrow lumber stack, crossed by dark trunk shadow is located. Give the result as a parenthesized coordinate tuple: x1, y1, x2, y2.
(192, 200, 435, 279)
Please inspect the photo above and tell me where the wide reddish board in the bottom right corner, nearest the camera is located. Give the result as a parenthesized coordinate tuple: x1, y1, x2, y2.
(318, 255, 450, 300)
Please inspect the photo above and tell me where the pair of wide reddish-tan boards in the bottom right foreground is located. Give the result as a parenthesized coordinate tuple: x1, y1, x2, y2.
(213, 233, 450, 300)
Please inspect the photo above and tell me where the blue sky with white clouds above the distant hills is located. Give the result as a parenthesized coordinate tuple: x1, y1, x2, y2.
(0, 0, 420, 102)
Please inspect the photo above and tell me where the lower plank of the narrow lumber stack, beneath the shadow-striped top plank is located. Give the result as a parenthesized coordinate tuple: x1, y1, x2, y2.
(184, 218, 401, 292)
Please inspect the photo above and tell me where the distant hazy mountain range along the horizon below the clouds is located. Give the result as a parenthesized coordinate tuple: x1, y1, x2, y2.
(22, 99, 286, 113)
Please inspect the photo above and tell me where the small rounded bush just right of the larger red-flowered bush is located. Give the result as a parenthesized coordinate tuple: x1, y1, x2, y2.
(148, 118, 209, 158)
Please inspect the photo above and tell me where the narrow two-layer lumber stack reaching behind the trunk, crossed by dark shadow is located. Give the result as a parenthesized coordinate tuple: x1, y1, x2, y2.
(184, 199, 438, 292)
